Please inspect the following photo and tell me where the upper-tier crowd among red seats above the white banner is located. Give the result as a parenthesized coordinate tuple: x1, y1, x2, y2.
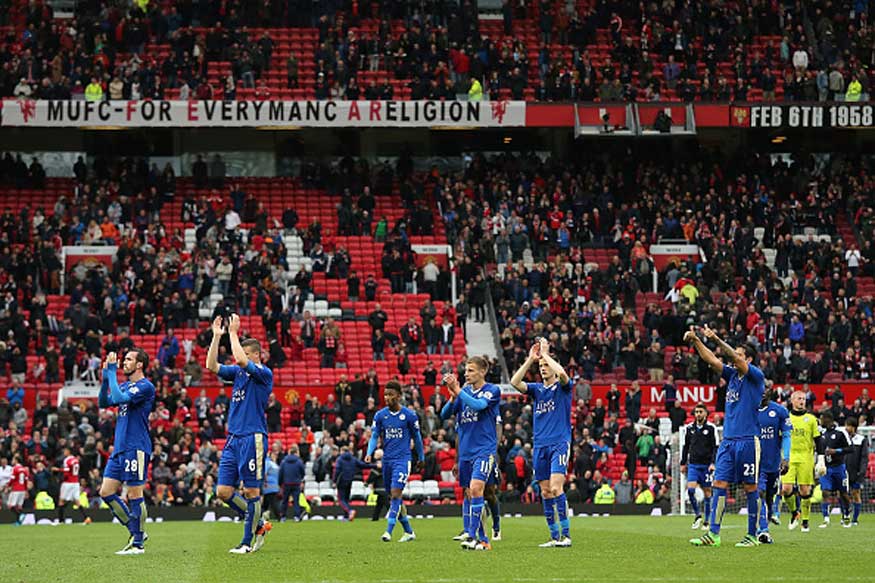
(0, 0, 875, 101)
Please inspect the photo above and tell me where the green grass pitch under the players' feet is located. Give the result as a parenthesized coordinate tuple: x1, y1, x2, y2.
(0, 515, 875, 583)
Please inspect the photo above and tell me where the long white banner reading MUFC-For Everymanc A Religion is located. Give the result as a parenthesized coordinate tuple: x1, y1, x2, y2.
(2, 100, 526, 128)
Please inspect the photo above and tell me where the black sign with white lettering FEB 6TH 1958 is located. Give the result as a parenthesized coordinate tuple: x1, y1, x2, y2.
(730, 103, 875, 129)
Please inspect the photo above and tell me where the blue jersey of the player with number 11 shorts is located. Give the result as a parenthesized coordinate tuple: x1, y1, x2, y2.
(453, 383, 501, 460)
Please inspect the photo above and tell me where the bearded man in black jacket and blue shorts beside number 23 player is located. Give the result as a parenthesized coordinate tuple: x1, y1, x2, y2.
(681, 403, 719, 528)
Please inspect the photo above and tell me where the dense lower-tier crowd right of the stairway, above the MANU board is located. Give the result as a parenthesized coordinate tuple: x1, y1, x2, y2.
(440, 152, 875, 383)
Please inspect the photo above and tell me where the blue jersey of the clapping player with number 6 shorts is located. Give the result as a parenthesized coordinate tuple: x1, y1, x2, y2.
(219, 360, 273, 435)
